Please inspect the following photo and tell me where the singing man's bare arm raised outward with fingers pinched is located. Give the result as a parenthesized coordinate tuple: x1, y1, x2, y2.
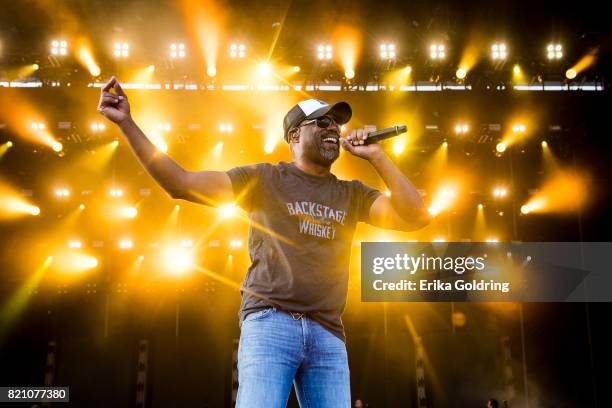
(98, 77, 234, 206)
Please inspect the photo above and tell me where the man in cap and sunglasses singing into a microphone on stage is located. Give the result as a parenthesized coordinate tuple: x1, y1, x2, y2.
(98, 77, 429, 408)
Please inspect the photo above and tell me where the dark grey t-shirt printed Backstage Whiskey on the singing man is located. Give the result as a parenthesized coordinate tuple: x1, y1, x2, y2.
(227, 162, 380, 340)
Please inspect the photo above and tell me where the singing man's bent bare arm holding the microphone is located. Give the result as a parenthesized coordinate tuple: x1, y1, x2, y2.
(342, 129, 431, 231)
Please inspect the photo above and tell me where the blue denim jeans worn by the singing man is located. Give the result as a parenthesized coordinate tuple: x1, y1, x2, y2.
(236, 308, 351, 408)
